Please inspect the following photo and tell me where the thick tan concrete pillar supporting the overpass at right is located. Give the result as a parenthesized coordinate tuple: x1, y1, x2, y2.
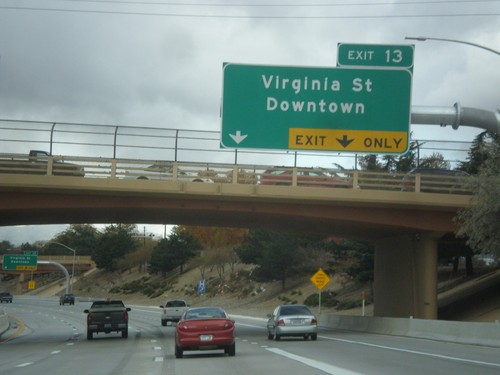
(374, 233, 442, 319)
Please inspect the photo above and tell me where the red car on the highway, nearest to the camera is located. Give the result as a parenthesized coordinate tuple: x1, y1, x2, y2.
(175, 307, 236, 358)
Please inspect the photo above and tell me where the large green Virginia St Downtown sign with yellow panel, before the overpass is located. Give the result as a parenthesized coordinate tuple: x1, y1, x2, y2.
(221, 63, 412, 154)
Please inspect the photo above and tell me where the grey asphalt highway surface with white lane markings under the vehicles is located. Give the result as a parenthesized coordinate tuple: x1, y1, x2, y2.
(0, 296, 500, 375)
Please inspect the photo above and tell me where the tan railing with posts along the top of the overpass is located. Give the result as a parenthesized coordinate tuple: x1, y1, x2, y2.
(0, 154, 472, 194)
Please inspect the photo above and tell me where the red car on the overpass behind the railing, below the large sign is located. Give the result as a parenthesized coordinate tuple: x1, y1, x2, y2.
(259, 167, 352, 188)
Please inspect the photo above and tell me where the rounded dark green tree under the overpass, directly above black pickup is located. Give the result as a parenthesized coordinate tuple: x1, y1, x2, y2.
(92, 224, 138, 271)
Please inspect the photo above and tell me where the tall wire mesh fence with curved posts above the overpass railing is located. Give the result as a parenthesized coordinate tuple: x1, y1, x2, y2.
(0, 119, 471, 169)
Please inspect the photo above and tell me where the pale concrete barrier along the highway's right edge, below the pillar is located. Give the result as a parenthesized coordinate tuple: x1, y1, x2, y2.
(319, 313, 500, 347)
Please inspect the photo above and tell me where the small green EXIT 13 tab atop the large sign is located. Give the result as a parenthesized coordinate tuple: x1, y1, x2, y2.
(337, 43, 414, 69)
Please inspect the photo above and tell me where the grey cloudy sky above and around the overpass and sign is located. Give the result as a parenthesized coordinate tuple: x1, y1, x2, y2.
(0, 0, 500, 243)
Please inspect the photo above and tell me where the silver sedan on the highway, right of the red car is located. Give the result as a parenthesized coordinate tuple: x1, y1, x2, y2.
(267, 305, 318, 341)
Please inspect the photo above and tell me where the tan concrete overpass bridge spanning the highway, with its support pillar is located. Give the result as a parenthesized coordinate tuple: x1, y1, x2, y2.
(0, 157, 471, 319)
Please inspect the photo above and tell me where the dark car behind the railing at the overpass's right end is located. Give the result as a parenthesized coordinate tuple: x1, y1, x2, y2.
(401, 167, 471, 194)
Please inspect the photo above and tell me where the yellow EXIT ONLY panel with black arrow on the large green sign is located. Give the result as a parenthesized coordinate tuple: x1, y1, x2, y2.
(288, 128, 408, 154)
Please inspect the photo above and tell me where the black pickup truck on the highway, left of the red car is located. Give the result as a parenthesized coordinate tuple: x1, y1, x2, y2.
(83, 300, 130, 340)
